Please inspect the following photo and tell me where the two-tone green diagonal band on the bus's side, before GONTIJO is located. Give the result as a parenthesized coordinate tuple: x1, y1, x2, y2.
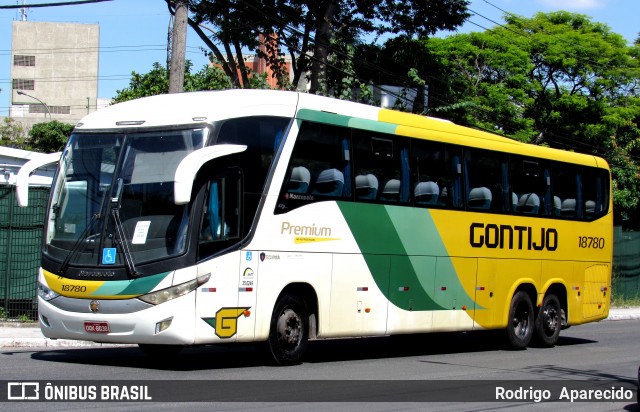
(338, 202, 479, 311)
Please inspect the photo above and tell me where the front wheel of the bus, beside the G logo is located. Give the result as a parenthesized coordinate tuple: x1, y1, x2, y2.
(267, 295, 309, 366)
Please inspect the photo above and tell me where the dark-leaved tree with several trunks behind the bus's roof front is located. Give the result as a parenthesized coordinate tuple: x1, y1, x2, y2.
(165, 0, 469, 94)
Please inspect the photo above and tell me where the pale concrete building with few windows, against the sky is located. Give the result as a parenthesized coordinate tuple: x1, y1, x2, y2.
(9, 21, 100, 130)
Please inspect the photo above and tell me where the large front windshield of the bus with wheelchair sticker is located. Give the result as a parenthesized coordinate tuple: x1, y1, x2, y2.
(44, 128, 207, 270)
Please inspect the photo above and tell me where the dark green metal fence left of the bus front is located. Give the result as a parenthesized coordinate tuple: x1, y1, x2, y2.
(0, 185, 49, 320)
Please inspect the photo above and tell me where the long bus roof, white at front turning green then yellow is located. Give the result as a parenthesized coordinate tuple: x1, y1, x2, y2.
(76, 89, 608, 168)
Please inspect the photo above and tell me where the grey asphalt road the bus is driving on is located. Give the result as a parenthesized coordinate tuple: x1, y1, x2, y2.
(0, 320, 640, 411)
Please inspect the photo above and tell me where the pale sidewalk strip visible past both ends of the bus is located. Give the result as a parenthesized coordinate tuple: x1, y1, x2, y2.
(0, 307, 640, 348)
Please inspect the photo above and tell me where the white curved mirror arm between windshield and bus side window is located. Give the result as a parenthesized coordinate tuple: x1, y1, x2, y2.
(173, 144, 247, 205)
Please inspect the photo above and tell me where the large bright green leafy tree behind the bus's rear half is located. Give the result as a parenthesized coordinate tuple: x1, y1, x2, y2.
(422, 12, 640, 218)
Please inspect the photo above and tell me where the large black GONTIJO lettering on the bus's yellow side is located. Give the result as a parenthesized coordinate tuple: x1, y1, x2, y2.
(469, 222, 558, 252)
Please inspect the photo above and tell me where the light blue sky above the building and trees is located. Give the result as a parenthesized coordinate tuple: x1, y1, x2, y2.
(0, 0, 640, 116)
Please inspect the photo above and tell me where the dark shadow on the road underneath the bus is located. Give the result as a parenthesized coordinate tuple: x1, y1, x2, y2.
(22, 331, 594, 371)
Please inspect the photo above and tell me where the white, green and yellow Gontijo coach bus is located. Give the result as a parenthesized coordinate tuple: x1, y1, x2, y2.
(23, 90, 613, 365)
